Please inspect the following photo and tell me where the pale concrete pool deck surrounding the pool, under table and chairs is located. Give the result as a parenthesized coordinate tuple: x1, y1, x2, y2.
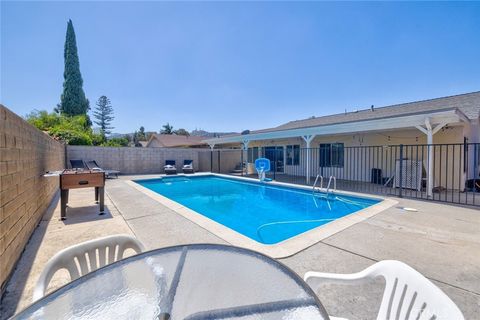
(0, 175, 480, 319)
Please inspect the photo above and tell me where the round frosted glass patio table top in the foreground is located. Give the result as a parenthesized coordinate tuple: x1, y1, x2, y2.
(14, 244, 328, 320)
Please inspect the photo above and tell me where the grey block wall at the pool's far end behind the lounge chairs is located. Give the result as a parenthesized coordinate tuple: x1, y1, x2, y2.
(67, 146, 204, 174)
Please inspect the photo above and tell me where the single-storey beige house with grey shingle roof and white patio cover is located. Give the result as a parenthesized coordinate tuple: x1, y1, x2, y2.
(205, 92, 480, 197)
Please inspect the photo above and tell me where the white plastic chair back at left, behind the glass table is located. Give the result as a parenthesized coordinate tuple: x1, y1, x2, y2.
(33, 235, 144, 301)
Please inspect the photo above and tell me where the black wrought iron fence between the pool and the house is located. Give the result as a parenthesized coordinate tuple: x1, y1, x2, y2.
(210, 143, 480, 206)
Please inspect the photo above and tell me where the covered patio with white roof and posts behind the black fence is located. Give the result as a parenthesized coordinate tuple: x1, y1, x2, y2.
(206, 108, 480, 205)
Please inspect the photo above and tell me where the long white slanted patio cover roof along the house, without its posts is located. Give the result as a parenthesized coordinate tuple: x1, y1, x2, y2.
(204, 108, 469, 145)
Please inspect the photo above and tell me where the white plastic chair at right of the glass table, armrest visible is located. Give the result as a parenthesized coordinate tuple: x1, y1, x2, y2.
(304, 260, 464, 320)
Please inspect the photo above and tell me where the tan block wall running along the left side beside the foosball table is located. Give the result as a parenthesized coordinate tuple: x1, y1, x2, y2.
(0, 105, 65, 294)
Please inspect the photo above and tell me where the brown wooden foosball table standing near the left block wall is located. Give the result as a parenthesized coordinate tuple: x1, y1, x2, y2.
(59, 169, 105, 220)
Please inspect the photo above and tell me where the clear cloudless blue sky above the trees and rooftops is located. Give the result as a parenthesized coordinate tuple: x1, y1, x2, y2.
(0, 1, 480, 132)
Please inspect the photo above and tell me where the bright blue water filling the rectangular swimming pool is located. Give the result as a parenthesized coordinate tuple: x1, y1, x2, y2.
(135, 175, 380, 244)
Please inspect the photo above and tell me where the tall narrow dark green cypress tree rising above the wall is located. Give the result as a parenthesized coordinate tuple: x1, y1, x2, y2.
(58, 20, 90, 116)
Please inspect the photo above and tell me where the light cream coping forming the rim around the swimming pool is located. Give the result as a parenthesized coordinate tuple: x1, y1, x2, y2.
(125, 172, 398, 258)
